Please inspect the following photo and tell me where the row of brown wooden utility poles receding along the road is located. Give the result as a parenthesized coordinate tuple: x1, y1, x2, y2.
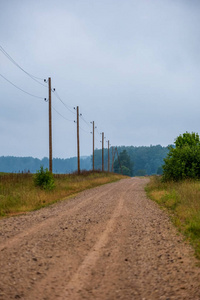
(48, 77, 119, 174)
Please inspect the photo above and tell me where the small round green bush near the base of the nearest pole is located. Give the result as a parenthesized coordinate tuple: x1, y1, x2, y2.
(34, 166, 55, 190)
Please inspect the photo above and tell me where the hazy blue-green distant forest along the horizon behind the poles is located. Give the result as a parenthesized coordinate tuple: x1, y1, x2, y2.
(0, 145, 168, 176)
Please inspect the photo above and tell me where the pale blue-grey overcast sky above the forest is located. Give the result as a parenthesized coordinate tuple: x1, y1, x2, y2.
(0, 0, 200, 158)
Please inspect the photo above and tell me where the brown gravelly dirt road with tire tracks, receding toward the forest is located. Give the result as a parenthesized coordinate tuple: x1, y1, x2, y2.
(0, 178, 200, 300)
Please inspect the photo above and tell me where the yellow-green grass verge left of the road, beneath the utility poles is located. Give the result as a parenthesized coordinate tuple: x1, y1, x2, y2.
(0, 172, 125, 217)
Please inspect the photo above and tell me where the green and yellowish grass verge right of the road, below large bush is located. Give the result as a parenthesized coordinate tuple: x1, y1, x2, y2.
(146, 176, 200, 259)
